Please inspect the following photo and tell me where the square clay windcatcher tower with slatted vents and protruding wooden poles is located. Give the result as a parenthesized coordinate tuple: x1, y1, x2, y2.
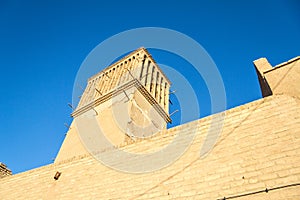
(56, 48, 171, 161)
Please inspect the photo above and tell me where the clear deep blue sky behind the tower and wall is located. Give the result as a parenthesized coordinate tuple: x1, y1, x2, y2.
(0, 0, 300, 173)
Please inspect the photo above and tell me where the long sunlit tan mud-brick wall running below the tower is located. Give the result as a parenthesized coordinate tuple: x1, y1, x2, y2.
(0, 56, 300, 200)
